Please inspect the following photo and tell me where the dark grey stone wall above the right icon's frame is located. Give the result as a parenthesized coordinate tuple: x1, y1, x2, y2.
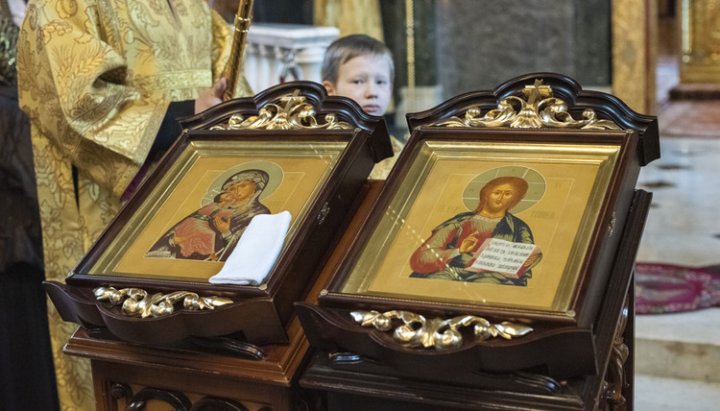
(435, 0, 610, 98)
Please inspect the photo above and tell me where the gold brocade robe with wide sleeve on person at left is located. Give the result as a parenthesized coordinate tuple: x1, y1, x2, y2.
(17, 0, 231, 410)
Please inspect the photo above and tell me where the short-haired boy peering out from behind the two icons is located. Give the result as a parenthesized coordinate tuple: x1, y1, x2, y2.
(320, 34, 403, 180)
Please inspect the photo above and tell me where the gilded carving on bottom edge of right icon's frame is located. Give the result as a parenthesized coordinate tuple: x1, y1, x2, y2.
(350, 310, 533, 350)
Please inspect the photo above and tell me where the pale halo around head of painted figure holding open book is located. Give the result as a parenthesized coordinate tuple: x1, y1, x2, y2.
(463, 166, 545, 213)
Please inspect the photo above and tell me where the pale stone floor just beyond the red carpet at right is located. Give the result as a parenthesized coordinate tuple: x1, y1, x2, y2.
(638, 138, 720, 266)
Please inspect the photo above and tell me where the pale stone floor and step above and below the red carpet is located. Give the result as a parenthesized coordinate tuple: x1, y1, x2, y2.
(634, 13, 720, 411)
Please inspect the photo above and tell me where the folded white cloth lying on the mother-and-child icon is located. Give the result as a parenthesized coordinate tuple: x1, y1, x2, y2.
(208, 211, 291, 285)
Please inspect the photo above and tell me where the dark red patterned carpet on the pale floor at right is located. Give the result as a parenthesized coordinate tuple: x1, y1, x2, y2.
(635, 263, 720, 314)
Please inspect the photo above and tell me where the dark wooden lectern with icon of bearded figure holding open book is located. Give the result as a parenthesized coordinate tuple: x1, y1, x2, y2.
(296, 73, 659, 410)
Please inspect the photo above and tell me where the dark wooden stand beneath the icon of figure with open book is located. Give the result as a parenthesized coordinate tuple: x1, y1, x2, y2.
(300, 191, 652, 411)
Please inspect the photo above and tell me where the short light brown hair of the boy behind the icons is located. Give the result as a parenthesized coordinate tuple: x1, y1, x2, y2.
(320, 34, 395, 84)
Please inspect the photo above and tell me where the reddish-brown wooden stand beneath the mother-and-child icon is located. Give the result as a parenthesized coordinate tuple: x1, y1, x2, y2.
(65, 181, 382, 411)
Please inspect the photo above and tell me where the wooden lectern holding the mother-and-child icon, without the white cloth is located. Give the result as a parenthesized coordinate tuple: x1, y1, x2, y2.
(46, 82, 392, 410)
